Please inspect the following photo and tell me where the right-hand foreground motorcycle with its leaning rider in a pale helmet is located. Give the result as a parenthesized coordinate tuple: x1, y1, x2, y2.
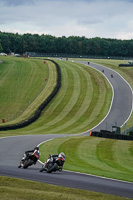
(40, 154, 65, 173)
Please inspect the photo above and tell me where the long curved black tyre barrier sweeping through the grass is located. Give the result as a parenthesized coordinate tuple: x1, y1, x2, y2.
(0, 59, 61, 131)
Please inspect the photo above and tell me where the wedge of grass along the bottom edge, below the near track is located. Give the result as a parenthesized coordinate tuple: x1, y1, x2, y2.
(0, 177, 127, 200)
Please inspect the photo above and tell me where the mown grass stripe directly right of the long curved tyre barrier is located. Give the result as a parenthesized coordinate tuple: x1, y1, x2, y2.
(27, 63, 73, 131)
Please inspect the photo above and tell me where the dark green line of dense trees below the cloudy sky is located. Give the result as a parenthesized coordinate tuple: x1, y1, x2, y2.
(0, 32, 133, 57)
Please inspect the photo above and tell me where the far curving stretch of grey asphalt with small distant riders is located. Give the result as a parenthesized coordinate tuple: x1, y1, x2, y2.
(78, 62, 133, 131)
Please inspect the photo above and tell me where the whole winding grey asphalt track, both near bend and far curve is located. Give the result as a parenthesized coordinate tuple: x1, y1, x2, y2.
(0, 62, 133, 198)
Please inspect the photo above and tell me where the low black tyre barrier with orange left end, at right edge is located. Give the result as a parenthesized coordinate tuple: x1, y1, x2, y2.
(91, 131, 133, 140)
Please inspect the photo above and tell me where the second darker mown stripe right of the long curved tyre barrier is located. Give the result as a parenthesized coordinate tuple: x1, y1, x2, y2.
(47, 65, 93, 133)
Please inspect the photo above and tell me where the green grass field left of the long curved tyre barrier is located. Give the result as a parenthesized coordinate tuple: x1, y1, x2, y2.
(0, 57, 57, 125)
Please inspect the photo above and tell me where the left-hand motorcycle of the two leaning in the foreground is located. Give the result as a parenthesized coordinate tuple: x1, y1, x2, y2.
(18, 151, 40, 169)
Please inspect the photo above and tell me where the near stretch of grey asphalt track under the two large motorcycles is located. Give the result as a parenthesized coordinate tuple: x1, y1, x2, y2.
(0, 135, 133, 198)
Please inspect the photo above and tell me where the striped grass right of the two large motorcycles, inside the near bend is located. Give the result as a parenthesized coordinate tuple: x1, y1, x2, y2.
(40, 136, 133, 182)
